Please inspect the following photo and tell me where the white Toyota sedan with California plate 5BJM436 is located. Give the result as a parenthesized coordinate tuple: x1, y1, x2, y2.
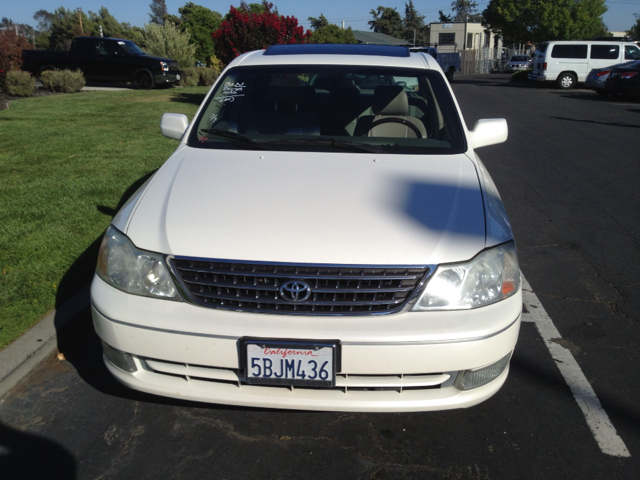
(91, 44, 522, 411)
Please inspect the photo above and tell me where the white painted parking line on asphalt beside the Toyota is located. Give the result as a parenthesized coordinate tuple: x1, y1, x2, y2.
(522, 276, 631, 457)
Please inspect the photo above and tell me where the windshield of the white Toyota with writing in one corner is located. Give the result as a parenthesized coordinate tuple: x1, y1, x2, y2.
(188, 65, 466, 154)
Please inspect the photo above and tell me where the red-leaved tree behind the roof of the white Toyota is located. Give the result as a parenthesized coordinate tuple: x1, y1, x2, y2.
(211, 0, 311, 64)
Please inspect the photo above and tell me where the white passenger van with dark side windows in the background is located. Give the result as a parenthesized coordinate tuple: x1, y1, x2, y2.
(529, 40, 640, 90)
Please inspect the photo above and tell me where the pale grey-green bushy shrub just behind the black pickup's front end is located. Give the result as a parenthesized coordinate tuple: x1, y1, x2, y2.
(143, 22, 196, 68)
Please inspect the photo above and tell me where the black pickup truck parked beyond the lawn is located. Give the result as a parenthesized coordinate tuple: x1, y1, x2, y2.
(22, 37, 181, 88)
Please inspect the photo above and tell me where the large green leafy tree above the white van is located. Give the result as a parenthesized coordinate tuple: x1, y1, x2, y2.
(482, 0, 607, 43)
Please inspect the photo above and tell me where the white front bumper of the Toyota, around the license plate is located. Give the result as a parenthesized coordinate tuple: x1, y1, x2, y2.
(92, 278, 522, 412)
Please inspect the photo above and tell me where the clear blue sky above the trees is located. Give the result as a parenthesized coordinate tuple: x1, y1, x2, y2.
(0, 0, 640, 31)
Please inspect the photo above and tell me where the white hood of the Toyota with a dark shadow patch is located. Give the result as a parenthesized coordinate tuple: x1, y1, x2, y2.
(124, 147, 485, 265)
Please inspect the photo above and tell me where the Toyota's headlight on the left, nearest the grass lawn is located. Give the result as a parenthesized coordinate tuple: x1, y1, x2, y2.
(96, 226, 181, 300)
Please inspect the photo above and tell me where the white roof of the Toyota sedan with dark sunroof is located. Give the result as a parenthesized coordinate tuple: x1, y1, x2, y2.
(229, 44, 437, 68)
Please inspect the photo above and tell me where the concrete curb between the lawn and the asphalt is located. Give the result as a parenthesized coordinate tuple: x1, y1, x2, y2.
(0, 285, 90, 397)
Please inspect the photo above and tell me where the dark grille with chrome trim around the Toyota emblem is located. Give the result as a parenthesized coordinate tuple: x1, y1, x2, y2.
(169, 257, 429, 315)
